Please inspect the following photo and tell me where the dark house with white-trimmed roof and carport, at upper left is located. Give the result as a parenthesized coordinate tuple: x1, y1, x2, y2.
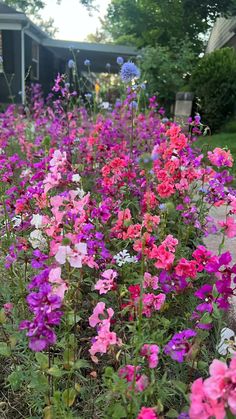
(0, 3, 137, 104)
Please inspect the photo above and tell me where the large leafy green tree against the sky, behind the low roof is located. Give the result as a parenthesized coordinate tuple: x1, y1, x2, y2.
(105, 0, 236, 53)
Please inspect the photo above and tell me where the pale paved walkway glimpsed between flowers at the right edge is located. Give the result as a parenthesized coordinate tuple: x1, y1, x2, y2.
(204, 205, 236, 331)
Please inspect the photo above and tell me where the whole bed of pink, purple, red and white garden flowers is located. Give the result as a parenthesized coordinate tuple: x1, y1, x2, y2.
(0, 67, 236, 419)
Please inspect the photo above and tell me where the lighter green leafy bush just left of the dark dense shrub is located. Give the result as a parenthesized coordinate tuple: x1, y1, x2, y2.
(141, 42, 197, 109)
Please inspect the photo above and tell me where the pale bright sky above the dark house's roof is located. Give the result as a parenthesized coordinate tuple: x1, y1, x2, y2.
(41, 0, 110, 41)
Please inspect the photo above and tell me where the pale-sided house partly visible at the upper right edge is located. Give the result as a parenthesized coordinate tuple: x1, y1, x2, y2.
(206, 16, 236, 53)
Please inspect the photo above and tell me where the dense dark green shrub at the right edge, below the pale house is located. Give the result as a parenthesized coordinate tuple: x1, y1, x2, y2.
(191, 48, 236, 131)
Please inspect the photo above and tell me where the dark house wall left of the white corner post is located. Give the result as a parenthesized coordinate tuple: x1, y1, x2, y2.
(0, 30, 21, 103)
